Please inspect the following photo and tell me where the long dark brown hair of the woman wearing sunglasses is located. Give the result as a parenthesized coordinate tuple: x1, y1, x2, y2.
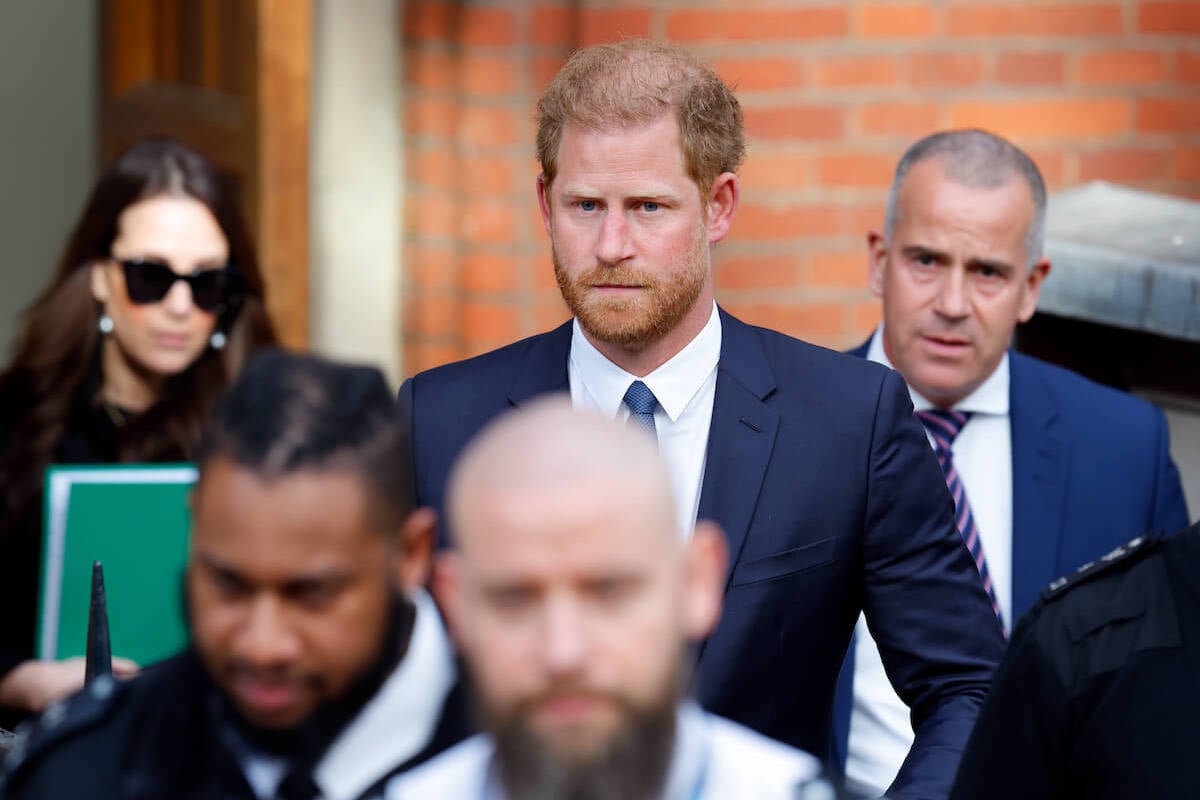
(0, 139, 275, 535)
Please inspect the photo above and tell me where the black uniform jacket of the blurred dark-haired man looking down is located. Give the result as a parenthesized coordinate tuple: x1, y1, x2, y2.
(0, 652, 467, 800)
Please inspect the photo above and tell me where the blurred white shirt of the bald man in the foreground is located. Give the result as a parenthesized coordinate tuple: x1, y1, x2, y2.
(384, 703, 832, 800)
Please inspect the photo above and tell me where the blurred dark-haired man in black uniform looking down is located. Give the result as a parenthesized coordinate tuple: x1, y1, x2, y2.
(5, 353, 466, 800)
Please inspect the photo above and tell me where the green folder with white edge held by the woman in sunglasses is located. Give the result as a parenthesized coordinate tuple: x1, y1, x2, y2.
(37, 464, 196, 666)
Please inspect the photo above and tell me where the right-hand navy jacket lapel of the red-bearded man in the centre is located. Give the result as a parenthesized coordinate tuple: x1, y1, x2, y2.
(698, 311, 779, 588)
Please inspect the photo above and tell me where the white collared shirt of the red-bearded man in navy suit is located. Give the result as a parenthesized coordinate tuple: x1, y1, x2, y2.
(566, 302, 721, 535)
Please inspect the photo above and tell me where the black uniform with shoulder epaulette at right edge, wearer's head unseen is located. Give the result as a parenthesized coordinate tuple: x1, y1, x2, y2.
(952, 525, 1200, 800)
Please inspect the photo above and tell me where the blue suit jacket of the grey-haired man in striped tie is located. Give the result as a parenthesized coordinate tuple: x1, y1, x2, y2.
(836, 342, 1188, 777)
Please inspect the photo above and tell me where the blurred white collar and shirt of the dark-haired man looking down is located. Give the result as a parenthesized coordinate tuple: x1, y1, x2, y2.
(240, 589, 457, 800)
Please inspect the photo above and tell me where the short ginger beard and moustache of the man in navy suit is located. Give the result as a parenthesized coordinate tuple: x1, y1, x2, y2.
(551, 228, 708, 353)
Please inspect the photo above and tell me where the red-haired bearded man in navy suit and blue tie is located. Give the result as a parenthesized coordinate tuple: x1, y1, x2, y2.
(401, 40, 1003, 798)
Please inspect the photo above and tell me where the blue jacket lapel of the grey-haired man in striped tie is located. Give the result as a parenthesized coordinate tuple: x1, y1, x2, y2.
(1009, 353, 1069, 621)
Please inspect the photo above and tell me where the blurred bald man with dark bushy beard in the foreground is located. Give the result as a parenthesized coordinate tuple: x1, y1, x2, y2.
(388, 399, 820, 800)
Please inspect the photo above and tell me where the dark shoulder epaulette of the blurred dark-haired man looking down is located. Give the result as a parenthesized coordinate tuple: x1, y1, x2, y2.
(0, 676, 128, 795)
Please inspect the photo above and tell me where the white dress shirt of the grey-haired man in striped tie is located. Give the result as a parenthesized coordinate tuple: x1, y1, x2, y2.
(846, 326, 1013, 795)
